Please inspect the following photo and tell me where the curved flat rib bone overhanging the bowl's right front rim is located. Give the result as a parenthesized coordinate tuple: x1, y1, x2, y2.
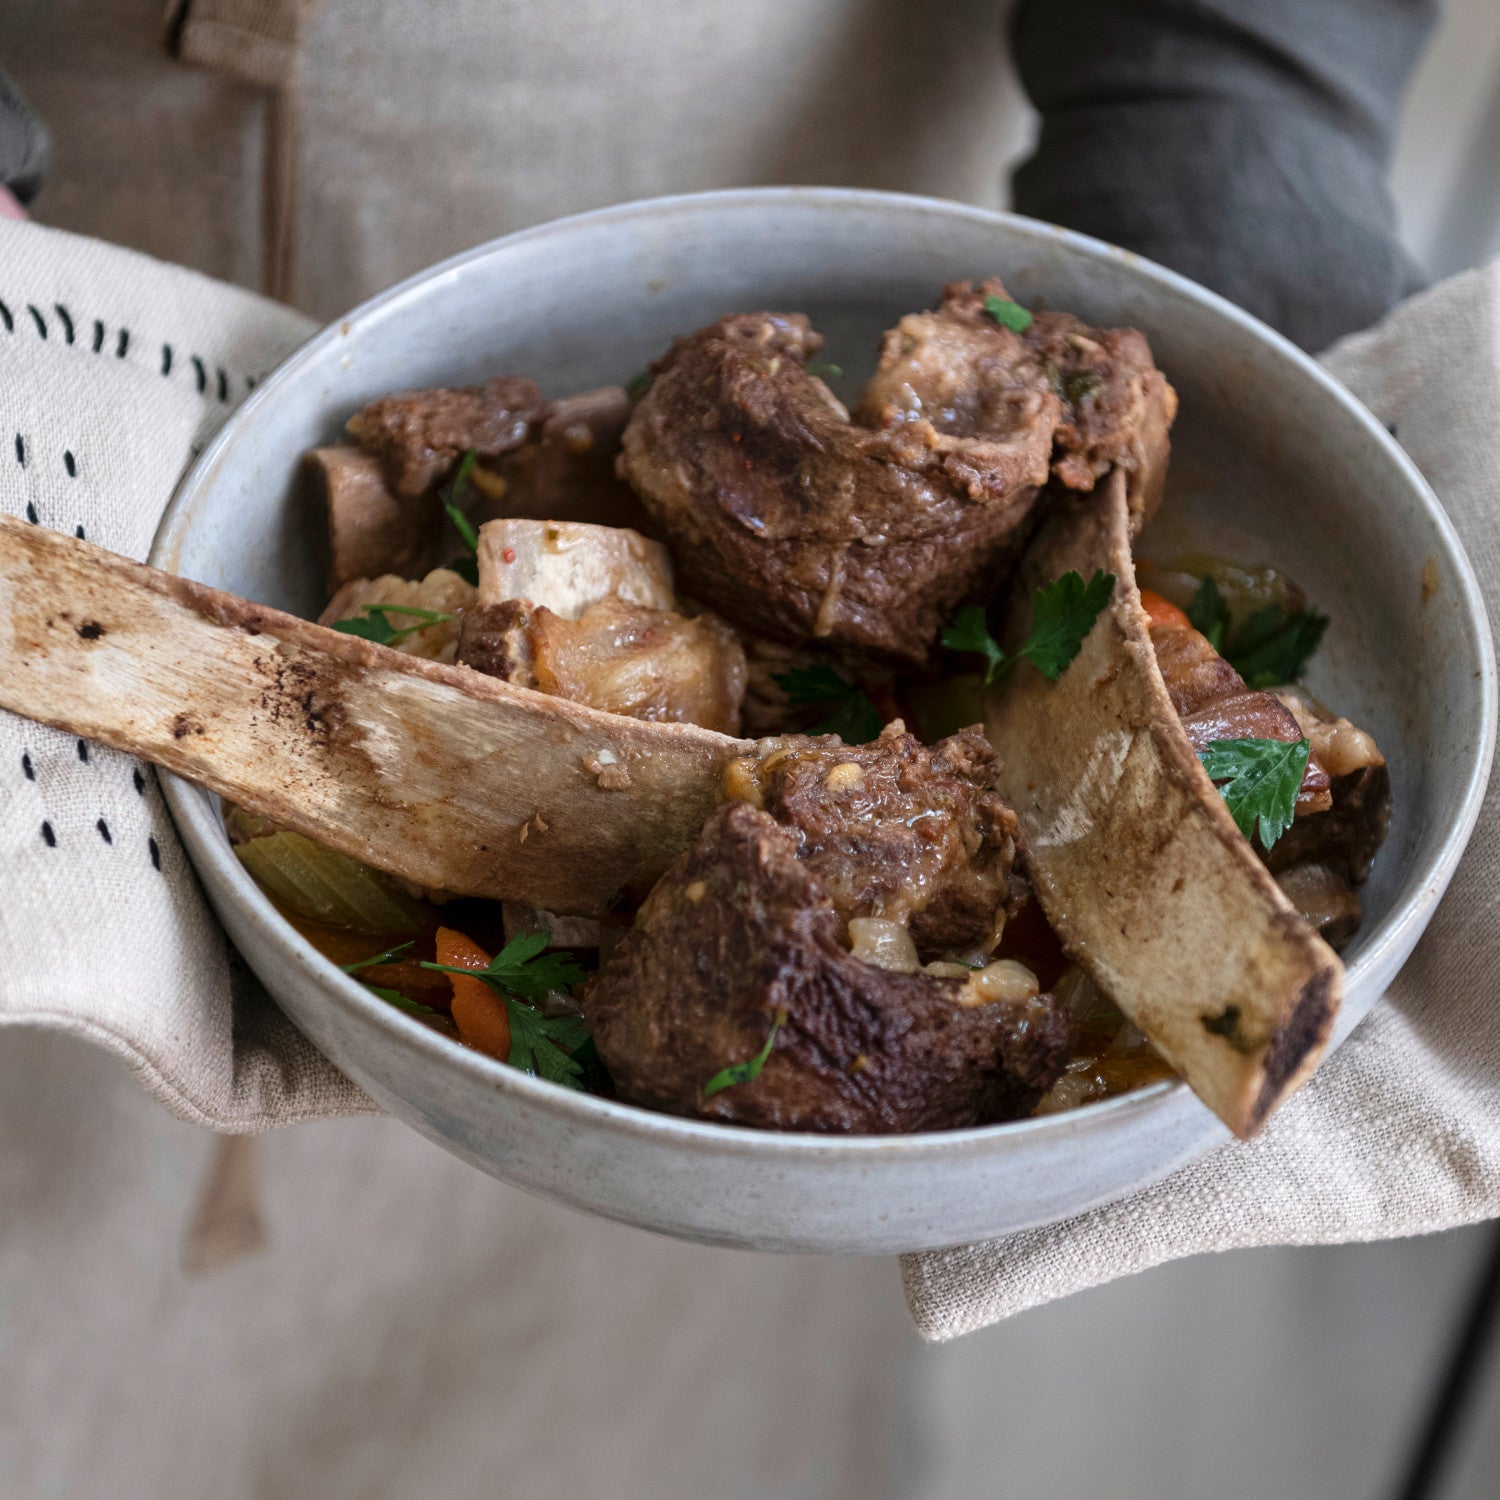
(989, 471, 1343, 1136)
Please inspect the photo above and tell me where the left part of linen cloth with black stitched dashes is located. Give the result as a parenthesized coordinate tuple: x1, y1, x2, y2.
(0, 211, 374, 1131)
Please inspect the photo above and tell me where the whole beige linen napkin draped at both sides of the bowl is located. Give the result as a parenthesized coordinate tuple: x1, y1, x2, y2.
(0, 222, 1500, 1338)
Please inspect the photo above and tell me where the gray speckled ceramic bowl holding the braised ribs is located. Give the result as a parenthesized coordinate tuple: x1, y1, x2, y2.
(153, 189, 1496, 1253)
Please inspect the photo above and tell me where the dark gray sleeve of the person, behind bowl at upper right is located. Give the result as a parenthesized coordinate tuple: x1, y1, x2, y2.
(1013, 0, 1437, 350)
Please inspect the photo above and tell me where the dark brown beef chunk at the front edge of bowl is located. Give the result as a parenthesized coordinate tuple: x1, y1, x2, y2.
(582, 803, 1071, 1133)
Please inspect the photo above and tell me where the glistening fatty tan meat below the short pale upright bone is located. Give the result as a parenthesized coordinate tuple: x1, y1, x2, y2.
(458, 599, 746, 735)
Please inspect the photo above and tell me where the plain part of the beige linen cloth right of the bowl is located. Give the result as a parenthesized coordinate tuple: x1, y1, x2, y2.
(902, 263, 1500, 1340)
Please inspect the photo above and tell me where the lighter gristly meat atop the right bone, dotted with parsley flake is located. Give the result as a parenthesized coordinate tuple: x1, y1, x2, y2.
(855, 278, 1178, 518)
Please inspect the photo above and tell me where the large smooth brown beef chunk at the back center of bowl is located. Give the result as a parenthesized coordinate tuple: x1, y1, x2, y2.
(620, 312, 1059, 663)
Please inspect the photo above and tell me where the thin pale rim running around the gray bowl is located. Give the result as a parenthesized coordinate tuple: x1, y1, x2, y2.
(149, 188, 1497, 1161)
